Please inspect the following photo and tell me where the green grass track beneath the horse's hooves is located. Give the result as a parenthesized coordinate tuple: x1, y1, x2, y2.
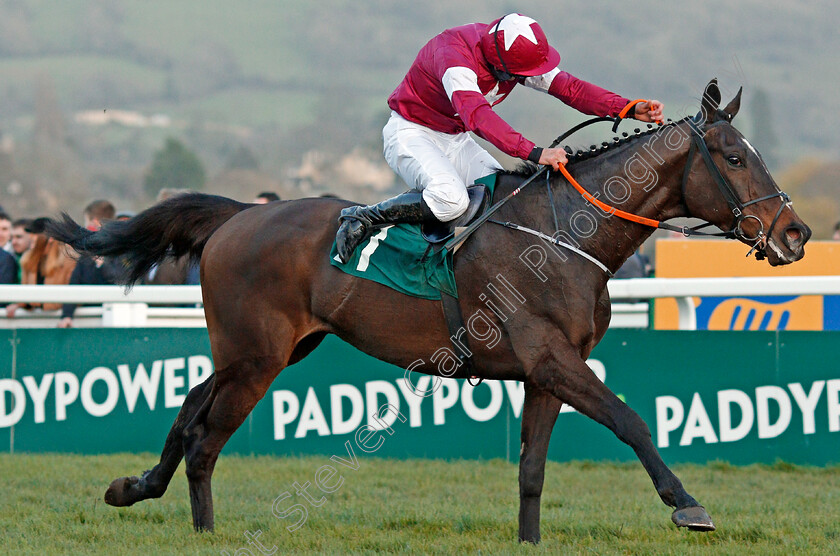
(0, 454, 840, 555)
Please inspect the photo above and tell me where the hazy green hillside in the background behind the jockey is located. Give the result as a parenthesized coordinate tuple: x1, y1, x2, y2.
(0, 0, 840, 216)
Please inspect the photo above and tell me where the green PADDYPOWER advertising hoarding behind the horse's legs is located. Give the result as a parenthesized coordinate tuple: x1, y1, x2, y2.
(0, 328, 840, 465)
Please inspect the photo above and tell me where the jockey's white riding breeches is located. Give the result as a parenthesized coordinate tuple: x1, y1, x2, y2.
(382, 112, 502, 222)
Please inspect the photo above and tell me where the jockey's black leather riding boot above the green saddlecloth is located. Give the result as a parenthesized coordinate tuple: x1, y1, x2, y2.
(335, 191, 436, 263)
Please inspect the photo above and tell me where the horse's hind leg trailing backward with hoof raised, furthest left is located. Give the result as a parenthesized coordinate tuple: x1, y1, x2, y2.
(105, 375, 215, 506)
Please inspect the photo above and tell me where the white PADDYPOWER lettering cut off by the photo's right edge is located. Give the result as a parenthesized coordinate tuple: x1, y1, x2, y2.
(656, 379, 840, 448)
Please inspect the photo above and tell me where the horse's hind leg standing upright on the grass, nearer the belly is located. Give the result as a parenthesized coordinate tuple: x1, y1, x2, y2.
(183, 357, 285, 531)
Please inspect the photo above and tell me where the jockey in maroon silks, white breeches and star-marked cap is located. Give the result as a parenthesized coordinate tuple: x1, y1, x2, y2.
(336, 13, 663, 262)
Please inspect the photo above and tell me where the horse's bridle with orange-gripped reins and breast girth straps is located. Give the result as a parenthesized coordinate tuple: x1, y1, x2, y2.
(444, 99, 791, 276)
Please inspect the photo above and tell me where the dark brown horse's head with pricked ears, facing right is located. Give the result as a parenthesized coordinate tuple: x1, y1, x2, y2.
(683, 79, 811, 266)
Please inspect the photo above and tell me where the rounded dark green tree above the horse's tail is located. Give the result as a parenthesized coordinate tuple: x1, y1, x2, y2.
(143, 137, 205, 197)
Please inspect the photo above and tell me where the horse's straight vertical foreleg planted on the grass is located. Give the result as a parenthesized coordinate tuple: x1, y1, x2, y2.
(519, 382, 563, 543)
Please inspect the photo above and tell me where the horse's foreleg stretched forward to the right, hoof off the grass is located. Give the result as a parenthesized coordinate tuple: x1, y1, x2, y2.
(533, 344, 715, 531)
